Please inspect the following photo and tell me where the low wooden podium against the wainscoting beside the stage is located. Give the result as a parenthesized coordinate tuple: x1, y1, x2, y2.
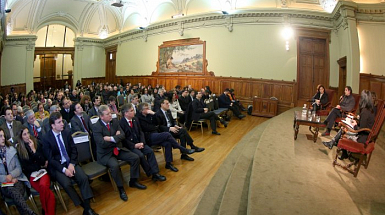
(251, 96, 278, 117)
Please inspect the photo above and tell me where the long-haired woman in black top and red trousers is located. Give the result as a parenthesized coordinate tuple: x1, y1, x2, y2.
(16, 127, 55, 215)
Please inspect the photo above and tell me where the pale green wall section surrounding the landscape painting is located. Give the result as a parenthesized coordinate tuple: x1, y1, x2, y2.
(116, 25, 297, 81)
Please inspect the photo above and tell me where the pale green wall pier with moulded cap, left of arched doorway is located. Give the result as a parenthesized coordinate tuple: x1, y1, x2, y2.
(1, 35, 37, 92)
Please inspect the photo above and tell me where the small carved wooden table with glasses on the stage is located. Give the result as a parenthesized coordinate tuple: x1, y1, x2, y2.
(293, 111, 326, 142)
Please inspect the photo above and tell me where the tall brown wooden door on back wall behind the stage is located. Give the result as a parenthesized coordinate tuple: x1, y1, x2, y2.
(297, 37, 329, 102)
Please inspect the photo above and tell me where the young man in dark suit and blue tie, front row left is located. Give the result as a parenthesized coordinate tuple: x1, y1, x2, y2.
(42, 112, 97, 215)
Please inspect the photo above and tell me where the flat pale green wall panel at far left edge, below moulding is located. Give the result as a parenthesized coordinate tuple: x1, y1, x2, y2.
(1, 46, 27, 86)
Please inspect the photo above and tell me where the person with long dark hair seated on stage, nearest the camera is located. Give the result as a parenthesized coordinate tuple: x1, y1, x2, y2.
(322, 90, 375, 160)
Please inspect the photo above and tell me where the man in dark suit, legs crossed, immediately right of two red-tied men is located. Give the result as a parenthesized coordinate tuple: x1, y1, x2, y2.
(136, 103, 195, 172)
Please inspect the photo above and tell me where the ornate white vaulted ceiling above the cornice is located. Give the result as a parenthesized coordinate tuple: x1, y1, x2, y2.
(5, 0, 383, 38)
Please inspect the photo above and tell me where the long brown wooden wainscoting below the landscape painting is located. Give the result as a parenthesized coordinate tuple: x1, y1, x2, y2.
(82, 75, 296, 113)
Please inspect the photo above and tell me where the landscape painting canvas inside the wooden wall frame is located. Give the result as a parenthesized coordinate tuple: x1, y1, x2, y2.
(159, 44, 204, 73)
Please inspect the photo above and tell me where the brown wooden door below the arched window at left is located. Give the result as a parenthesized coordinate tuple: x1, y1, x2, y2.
(40, 54, 56, 89)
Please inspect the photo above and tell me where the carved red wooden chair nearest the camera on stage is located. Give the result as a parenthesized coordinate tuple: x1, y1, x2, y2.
(333, 100, 385, 177)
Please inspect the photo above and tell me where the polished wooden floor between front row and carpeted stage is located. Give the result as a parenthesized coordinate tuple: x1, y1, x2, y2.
(4, 115, 268, 215)
